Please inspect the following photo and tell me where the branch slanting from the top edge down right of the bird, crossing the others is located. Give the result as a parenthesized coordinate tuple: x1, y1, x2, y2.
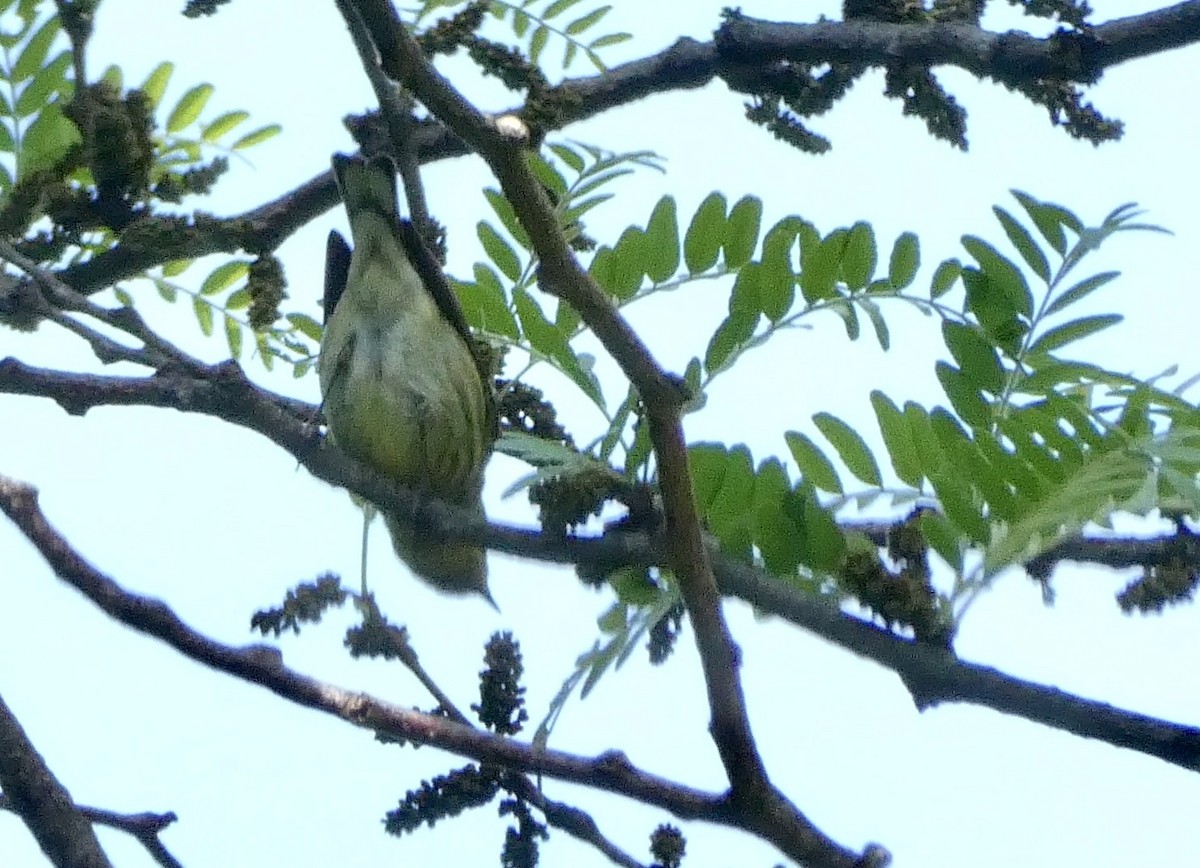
(355, 0, 782, 830)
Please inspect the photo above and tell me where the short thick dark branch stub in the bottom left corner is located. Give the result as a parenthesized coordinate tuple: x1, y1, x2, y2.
(0, 691, 113, 868)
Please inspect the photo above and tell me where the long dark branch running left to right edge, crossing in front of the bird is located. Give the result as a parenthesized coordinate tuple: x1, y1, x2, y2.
(0, 359, 1200, 771)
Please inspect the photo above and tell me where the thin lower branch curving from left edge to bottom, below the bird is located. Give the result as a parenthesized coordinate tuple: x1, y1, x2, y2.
(0, 475, 883, 868)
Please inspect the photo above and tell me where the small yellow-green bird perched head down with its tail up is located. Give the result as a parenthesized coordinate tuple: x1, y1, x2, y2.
(319, 154, 497, 606)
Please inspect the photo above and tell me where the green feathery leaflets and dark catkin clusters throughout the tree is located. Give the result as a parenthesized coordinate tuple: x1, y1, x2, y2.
(0, 0, 1200, 866)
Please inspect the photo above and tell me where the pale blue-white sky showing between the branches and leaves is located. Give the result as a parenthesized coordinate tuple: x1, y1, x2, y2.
(0, 0, 1200, 868)
